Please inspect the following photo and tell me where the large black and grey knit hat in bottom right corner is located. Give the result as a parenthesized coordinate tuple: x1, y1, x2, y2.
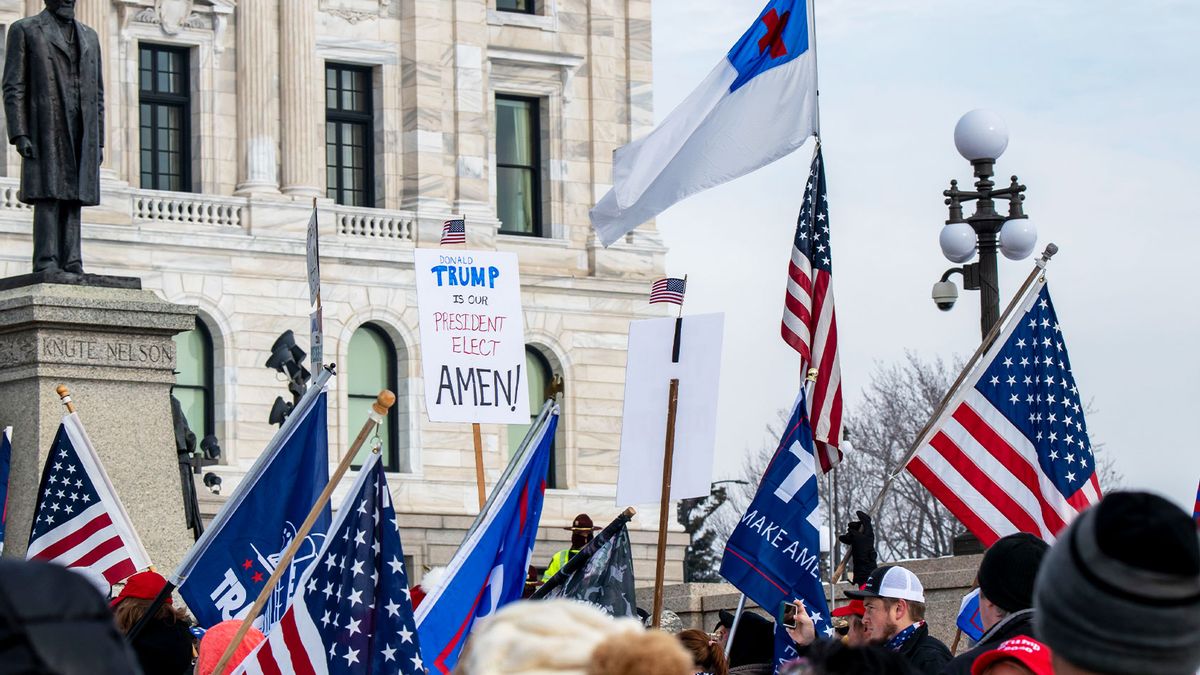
(1034, 492, 1200, 675)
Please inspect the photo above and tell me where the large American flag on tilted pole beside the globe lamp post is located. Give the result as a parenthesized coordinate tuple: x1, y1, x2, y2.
(908, 280, 1100, 546)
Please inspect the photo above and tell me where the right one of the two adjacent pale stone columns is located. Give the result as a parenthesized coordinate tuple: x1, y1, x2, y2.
(280, 0, 325, 197)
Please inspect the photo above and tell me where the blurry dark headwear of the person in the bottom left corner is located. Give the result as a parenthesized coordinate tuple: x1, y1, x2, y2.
(0, 558, 142, 675)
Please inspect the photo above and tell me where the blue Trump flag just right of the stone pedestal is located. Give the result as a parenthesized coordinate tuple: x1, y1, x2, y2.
(170, 369, 330, 633)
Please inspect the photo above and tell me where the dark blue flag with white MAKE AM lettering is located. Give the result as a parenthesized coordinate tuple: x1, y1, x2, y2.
(721, 390, 833, 669)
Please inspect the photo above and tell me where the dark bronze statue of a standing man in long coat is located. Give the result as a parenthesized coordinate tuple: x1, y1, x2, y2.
(4, 0, 104, 274)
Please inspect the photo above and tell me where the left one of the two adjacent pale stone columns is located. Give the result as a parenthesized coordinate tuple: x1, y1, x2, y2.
(234, 0, 280, 195)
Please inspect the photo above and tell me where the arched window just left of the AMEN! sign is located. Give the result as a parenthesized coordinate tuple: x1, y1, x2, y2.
(347, 323, 409, 471)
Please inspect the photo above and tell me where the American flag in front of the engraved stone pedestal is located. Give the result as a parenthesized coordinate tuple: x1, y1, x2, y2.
(25, 413, 150, 584)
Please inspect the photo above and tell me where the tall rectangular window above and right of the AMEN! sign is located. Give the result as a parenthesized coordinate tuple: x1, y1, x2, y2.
(496, 96, 541, 237)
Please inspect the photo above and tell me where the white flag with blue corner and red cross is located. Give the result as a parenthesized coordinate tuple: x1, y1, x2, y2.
(590, 0, 817, 246)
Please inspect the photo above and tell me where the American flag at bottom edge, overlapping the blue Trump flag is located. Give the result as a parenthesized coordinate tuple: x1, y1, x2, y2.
(234, 453, 425, 675)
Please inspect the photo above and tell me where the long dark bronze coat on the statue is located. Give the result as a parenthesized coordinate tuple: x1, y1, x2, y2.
(4, 10, 104, 205)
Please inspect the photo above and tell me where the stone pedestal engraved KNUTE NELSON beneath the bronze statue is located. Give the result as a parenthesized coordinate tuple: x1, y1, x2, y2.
(0, 275, 196, 574)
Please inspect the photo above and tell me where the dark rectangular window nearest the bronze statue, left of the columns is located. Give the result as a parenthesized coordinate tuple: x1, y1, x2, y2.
(138, 44, 192, 192)
